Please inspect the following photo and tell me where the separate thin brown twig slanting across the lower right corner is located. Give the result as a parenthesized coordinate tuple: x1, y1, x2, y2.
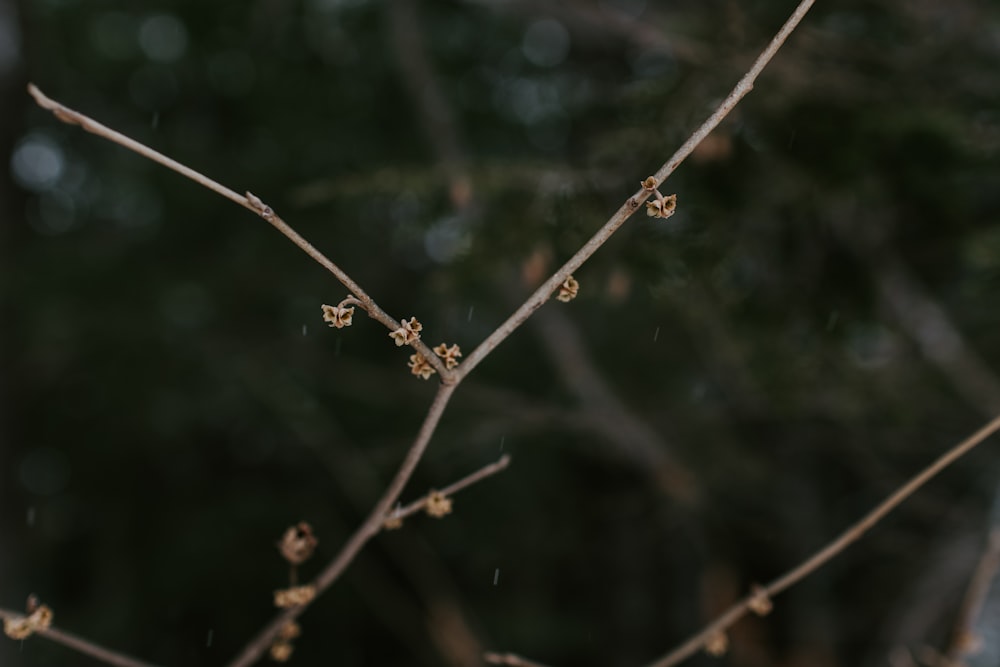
(649, 417, 1000, 667)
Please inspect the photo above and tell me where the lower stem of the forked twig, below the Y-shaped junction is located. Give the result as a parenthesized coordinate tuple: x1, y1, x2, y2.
(229, 384, 455, 667)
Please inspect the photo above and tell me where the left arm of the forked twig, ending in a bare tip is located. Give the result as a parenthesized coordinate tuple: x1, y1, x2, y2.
(28, 83, 455, 384)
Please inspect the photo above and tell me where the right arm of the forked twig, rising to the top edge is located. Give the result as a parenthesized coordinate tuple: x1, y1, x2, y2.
(456, 0, 815, 380)
